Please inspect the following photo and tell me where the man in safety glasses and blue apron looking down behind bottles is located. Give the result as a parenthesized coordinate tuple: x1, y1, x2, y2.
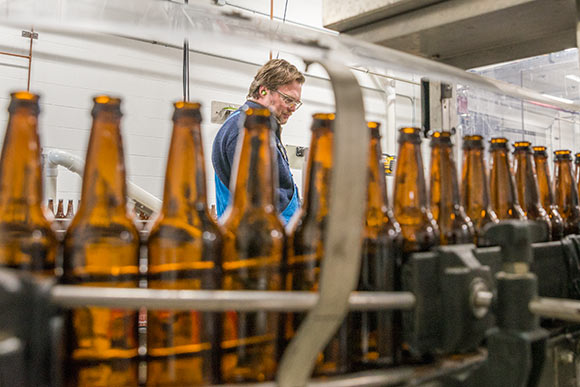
(211, 59, 304, 223)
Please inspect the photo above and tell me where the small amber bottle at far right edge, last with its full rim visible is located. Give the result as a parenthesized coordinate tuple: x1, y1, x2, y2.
(554, 150, 580, 235)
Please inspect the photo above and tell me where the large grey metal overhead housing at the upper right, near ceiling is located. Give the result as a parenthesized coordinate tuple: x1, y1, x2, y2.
(323, 0, 576, 68)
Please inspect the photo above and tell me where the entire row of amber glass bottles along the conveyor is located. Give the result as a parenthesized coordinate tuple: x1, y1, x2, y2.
(0, 88, 580, 386)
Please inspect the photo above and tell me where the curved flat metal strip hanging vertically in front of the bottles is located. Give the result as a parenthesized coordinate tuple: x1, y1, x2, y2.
(277, 60, 369, 387)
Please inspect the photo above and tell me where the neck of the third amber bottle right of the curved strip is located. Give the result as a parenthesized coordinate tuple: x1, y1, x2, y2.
(430, 145, 459, 220)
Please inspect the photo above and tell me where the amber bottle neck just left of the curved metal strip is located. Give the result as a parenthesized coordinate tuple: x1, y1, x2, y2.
(303, 126, 334, 220)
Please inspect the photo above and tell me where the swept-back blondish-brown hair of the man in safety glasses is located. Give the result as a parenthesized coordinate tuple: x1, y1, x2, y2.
(247, 59, 305, 98)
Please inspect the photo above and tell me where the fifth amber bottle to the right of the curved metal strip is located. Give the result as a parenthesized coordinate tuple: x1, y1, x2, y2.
(489, 137, 526, 220)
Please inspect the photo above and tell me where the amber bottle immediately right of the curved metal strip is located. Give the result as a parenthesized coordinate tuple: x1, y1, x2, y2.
(348, 122, 402, 370)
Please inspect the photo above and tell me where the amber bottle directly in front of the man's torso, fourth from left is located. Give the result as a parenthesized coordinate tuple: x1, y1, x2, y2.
(221, 108, 285, 383)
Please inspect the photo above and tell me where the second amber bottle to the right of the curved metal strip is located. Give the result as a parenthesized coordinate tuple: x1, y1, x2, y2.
(394, 128, 440, 253)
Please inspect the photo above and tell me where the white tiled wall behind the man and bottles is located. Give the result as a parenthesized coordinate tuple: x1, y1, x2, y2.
(0, 5, 419, 209)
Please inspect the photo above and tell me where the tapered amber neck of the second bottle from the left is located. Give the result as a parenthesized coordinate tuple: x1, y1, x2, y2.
(79, 109, 127, 214)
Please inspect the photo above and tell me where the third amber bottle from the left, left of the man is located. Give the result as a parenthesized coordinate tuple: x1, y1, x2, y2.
(147, 102, 223, 387)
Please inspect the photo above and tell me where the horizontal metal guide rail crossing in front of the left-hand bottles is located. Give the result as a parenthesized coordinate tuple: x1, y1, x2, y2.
(51, 285, 415, 311)
